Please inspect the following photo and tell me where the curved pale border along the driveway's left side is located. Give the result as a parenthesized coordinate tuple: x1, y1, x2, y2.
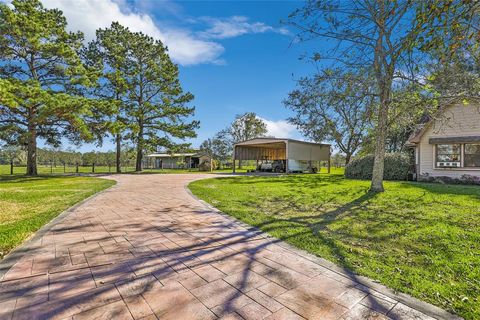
(0, 179, 117, 280)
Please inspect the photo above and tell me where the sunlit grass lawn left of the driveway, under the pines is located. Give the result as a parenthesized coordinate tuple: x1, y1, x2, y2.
(0, 175, 115, 259)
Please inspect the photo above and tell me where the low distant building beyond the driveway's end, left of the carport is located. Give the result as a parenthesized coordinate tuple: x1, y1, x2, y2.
(146, 152, 210, 169)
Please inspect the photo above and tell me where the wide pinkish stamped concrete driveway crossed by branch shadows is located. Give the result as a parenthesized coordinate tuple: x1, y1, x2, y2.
(0, 174, 458, 319)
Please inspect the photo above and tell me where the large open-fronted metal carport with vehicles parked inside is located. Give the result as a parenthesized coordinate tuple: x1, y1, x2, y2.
(233, 138, 330, 173)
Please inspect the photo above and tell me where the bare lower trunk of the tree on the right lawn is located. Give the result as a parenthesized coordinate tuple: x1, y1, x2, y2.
(370, 97, 388, 192)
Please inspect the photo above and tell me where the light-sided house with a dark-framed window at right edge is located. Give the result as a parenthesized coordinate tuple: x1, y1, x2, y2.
(407, 103, 480, 180)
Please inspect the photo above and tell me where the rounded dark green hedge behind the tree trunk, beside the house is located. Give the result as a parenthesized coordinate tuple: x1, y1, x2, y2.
(345, 153, 410, 180)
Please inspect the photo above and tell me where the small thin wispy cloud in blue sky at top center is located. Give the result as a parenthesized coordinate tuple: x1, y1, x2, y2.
(200, 16, 288, 39)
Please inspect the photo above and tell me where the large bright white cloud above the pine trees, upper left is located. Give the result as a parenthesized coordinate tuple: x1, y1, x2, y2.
(43, 0, 224, 65)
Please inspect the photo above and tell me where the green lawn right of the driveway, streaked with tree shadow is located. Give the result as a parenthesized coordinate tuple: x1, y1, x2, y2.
(189, 174, 480, 319)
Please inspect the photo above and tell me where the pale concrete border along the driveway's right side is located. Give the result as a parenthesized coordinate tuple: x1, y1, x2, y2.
(185, 178, 463, 320)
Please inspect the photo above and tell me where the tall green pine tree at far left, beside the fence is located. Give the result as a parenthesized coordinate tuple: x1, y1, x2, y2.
(0, 0, 94, 175)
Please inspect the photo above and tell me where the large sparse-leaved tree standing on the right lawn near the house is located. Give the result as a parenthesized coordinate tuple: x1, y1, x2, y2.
(288, 0, 480, 192)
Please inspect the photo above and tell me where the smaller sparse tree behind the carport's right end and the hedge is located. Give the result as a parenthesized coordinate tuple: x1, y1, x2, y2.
(284, 69, 375, 164)
